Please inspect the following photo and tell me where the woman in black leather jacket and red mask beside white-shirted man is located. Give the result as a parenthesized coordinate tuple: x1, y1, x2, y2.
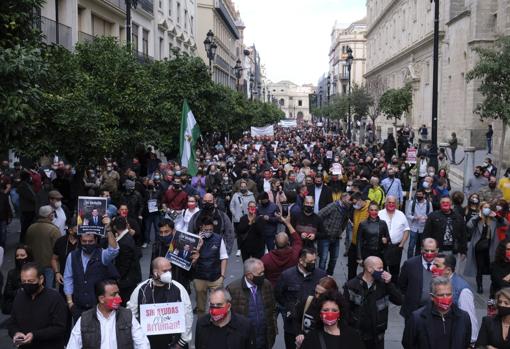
(356, 202, 390, 264)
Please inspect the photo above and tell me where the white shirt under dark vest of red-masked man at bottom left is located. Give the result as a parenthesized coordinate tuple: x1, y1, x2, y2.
(67, 307, 150, 349)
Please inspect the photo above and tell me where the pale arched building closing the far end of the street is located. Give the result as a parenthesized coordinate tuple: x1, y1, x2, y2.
(267, 80, 315, 122)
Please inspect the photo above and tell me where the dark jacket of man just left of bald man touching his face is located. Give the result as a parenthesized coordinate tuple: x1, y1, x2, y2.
(274, 266, 326, 334)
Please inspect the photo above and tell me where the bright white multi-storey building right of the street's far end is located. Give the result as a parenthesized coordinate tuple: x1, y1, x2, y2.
(326, 18, 367, 96)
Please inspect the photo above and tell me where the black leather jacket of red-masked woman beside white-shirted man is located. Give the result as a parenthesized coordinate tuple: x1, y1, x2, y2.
(356, 217, 390, 259)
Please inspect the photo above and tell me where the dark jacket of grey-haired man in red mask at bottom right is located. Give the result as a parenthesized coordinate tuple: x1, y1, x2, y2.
(402, 301, 471, 349)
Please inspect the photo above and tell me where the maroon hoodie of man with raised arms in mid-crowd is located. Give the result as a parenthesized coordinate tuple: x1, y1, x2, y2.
(261, 231, 303, 287)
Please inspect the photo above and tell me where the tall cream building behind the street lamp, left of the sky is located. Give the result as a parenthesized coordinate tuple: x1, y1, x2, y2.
(195, 0, 244, 89)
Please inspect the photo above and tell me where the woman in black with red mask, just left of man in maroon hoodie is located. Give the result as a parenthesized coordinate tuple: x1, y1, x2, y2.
(236, 201, 265, 262)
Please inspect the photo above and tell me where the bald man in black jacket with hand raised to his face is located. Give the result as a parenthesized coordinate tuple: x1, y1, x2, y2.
(344, 256, 402, 349)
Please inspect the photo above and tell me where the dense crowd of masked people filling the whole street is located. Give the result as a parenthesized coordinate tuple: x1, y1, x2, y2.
(0, 125, 510, 349)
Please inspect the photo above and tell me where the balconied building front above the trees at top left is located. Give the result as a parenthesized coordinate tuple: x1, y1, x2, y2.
(37, 0, 197, 59)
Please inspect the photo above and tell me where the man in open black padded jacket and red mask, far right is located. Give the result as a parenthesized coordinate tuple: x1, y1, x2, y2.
(423, 197, 467, 258)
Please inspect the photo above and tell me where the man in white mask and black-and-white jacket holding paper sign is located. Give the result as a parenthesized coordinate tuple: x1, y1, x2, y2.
(128, 257, 193, 349)
